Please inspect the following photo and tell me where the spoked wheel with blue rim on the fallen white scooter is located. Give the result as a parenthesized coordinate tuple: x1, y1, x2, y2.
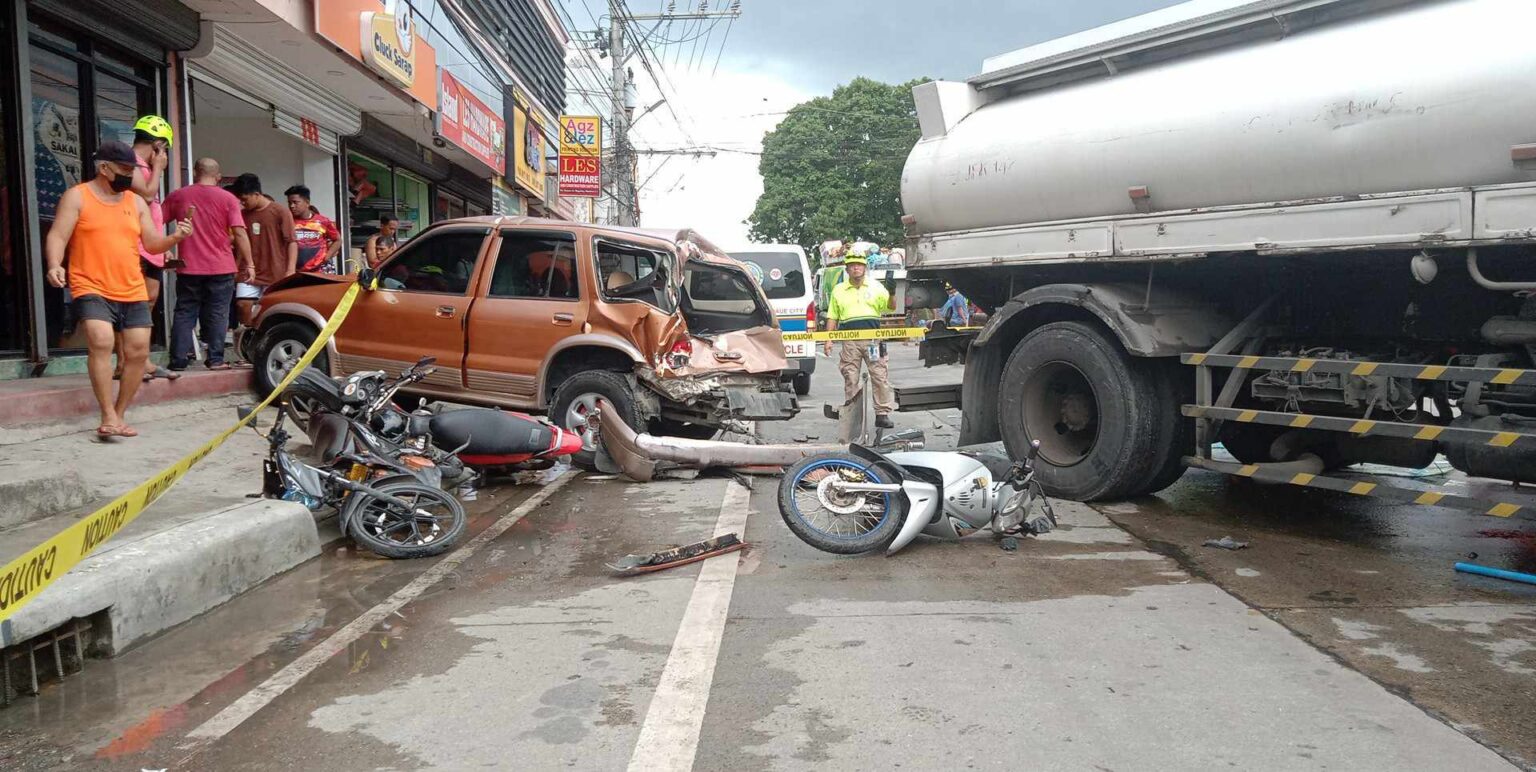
(779, 453, 906, 554)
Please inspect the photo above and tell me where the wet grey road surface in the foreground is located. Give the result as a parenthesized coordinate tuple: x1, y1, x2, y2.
(0, 345, 1536, 770)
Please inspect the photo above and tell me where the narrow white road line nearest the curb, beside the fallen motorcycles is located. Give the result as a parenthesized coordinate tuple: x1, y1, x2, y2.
(177, 471, 576, 751)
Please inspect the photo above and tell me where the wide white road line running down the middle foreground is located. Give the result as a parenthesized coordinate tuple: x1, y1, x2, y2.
(630, 482, 751, 772)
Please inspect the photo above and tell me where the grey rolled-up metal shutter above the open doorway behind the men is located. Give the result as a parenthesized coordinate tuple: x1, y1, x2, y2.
(187, 21, 362, 137)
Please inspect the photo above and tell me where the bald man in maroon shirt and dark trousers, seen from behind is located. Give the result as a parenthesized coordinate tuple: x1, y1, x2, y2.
(166, 158, 255, 370)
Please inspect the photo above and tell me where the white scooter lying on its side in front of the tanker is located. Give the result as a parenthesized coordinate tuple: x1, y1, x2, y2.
(779, 442, 1057, 556)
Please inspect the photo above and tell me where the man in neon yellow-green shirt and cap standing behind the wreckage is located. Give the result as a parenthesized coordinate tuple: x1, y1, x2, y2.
(823, 249, 895, 428)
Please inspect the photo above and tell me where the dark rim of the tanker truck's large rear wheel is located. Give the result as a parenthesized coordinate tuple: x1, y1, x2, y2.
(1025, 362, 1100, 467)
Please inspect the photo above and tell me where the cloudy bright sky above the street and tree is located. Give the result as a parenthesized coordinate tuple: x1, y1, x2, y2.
(568, 0, 1175, 244)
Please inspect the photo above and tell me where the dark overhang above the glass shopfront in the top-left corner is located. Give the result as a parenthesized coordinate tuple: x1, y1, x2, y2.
(30, 0, 201, 61)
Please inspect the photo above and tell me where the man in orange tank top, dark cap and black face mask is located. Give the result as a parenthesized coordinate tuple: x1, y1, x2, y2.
(43, 141, 192, 437)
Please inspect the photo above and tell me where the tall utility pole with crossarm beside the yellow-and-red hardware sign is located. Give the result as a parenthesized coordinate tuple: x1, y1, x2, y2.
(608, 0, 742, 226)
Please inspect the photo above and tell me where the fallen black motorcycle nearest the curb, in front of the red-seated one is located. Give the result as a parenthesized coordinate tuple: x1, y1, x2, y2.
(240, 407, 467, 559)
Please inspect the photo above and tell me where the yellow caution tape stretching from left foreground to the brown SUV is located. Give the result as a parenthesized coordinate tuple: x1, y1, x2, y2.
(0, 284, 359, 622)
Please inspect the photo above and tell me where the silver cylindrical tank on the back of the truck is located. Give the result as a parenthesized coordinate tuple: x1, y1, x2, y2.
(902, 0, 1536, 233)
